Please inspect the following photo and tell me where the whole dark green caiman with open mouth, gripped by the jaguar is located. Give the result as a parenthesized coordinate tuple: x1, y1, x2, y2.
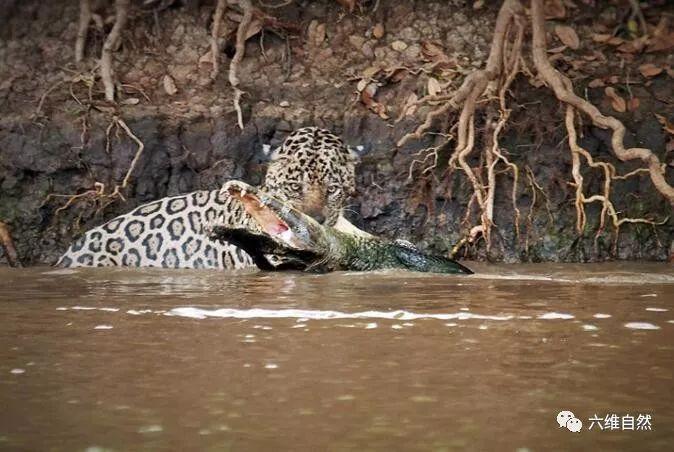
(209, 181, 473, 274)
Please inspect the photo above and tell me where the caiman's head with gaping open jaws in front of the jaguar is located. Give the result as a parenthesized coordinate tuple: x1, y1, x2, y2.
(209, 181, 330, 270)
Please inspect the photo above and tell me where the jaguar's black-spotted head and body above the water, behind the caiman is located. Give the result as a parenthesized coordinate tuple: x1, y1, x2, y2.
(57, 127, 356, 269)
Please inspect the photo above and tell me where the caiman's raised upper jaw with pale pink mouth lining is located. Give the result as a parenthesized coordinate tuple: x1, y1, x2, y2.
(224, 183, 312, 250)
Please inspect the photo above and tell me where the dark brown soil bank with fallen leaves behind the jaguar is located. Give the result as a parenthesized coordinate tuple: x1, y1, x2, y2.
(0, 0, 674, 264)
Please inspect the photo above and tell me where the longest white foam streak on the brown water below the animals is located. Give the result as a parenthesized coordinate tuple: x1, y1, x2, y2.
(165, 307, 516, 322)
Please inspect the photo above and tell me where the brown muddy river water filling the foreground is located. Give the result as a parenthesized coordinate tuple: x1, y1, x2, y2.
(0, 264, 674, 452)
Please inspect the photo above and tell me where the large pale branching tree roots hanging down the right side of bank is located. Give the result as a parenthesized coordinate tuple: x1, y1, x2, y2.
(398, 0, 674, 254)
